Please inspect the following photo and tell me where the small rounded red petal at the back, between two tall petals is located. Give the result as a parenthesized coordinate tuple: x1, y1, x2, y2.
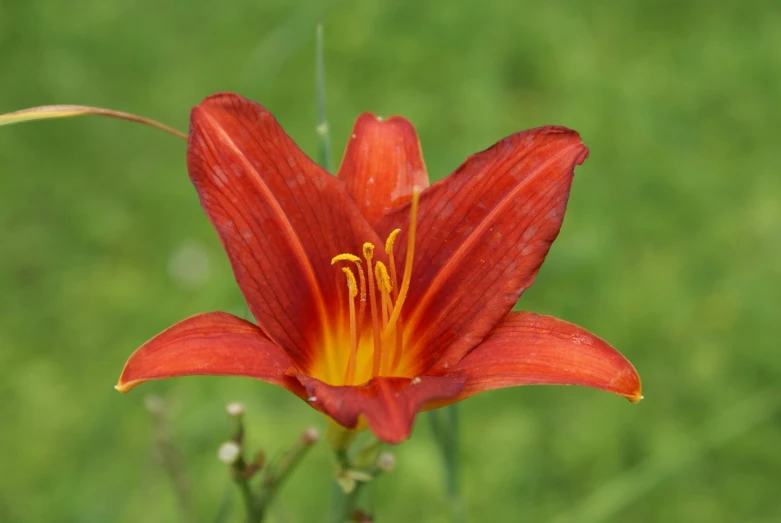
(338, 113, 428, 223)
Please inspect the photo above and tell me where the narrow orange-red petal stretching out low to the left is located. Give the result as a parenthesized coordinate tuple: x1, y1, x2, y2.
(116, 312, 303, 395)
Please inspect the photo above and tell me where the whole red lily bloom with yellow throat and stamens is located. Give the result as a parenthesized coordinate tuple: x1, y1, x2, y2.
(117, 94, 641, 443)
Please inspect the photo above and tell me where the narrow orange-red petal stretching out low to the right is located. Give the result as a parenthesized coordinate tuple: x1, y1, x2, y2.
(442, 312, 642, 402)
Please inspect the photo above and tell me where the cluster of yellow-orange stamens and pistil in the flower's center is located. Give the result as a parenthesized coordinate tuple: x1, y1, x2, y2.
(331, 189, 420, 385)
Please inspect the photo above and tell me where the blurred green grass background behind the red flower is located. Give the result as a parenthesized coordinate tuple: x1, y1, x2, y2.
(0, 0, 781, 523)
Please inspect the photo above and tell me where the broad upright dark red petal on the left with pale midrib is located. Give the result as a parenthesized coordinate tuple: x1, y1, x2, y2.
(187, 94, 380, 368)
